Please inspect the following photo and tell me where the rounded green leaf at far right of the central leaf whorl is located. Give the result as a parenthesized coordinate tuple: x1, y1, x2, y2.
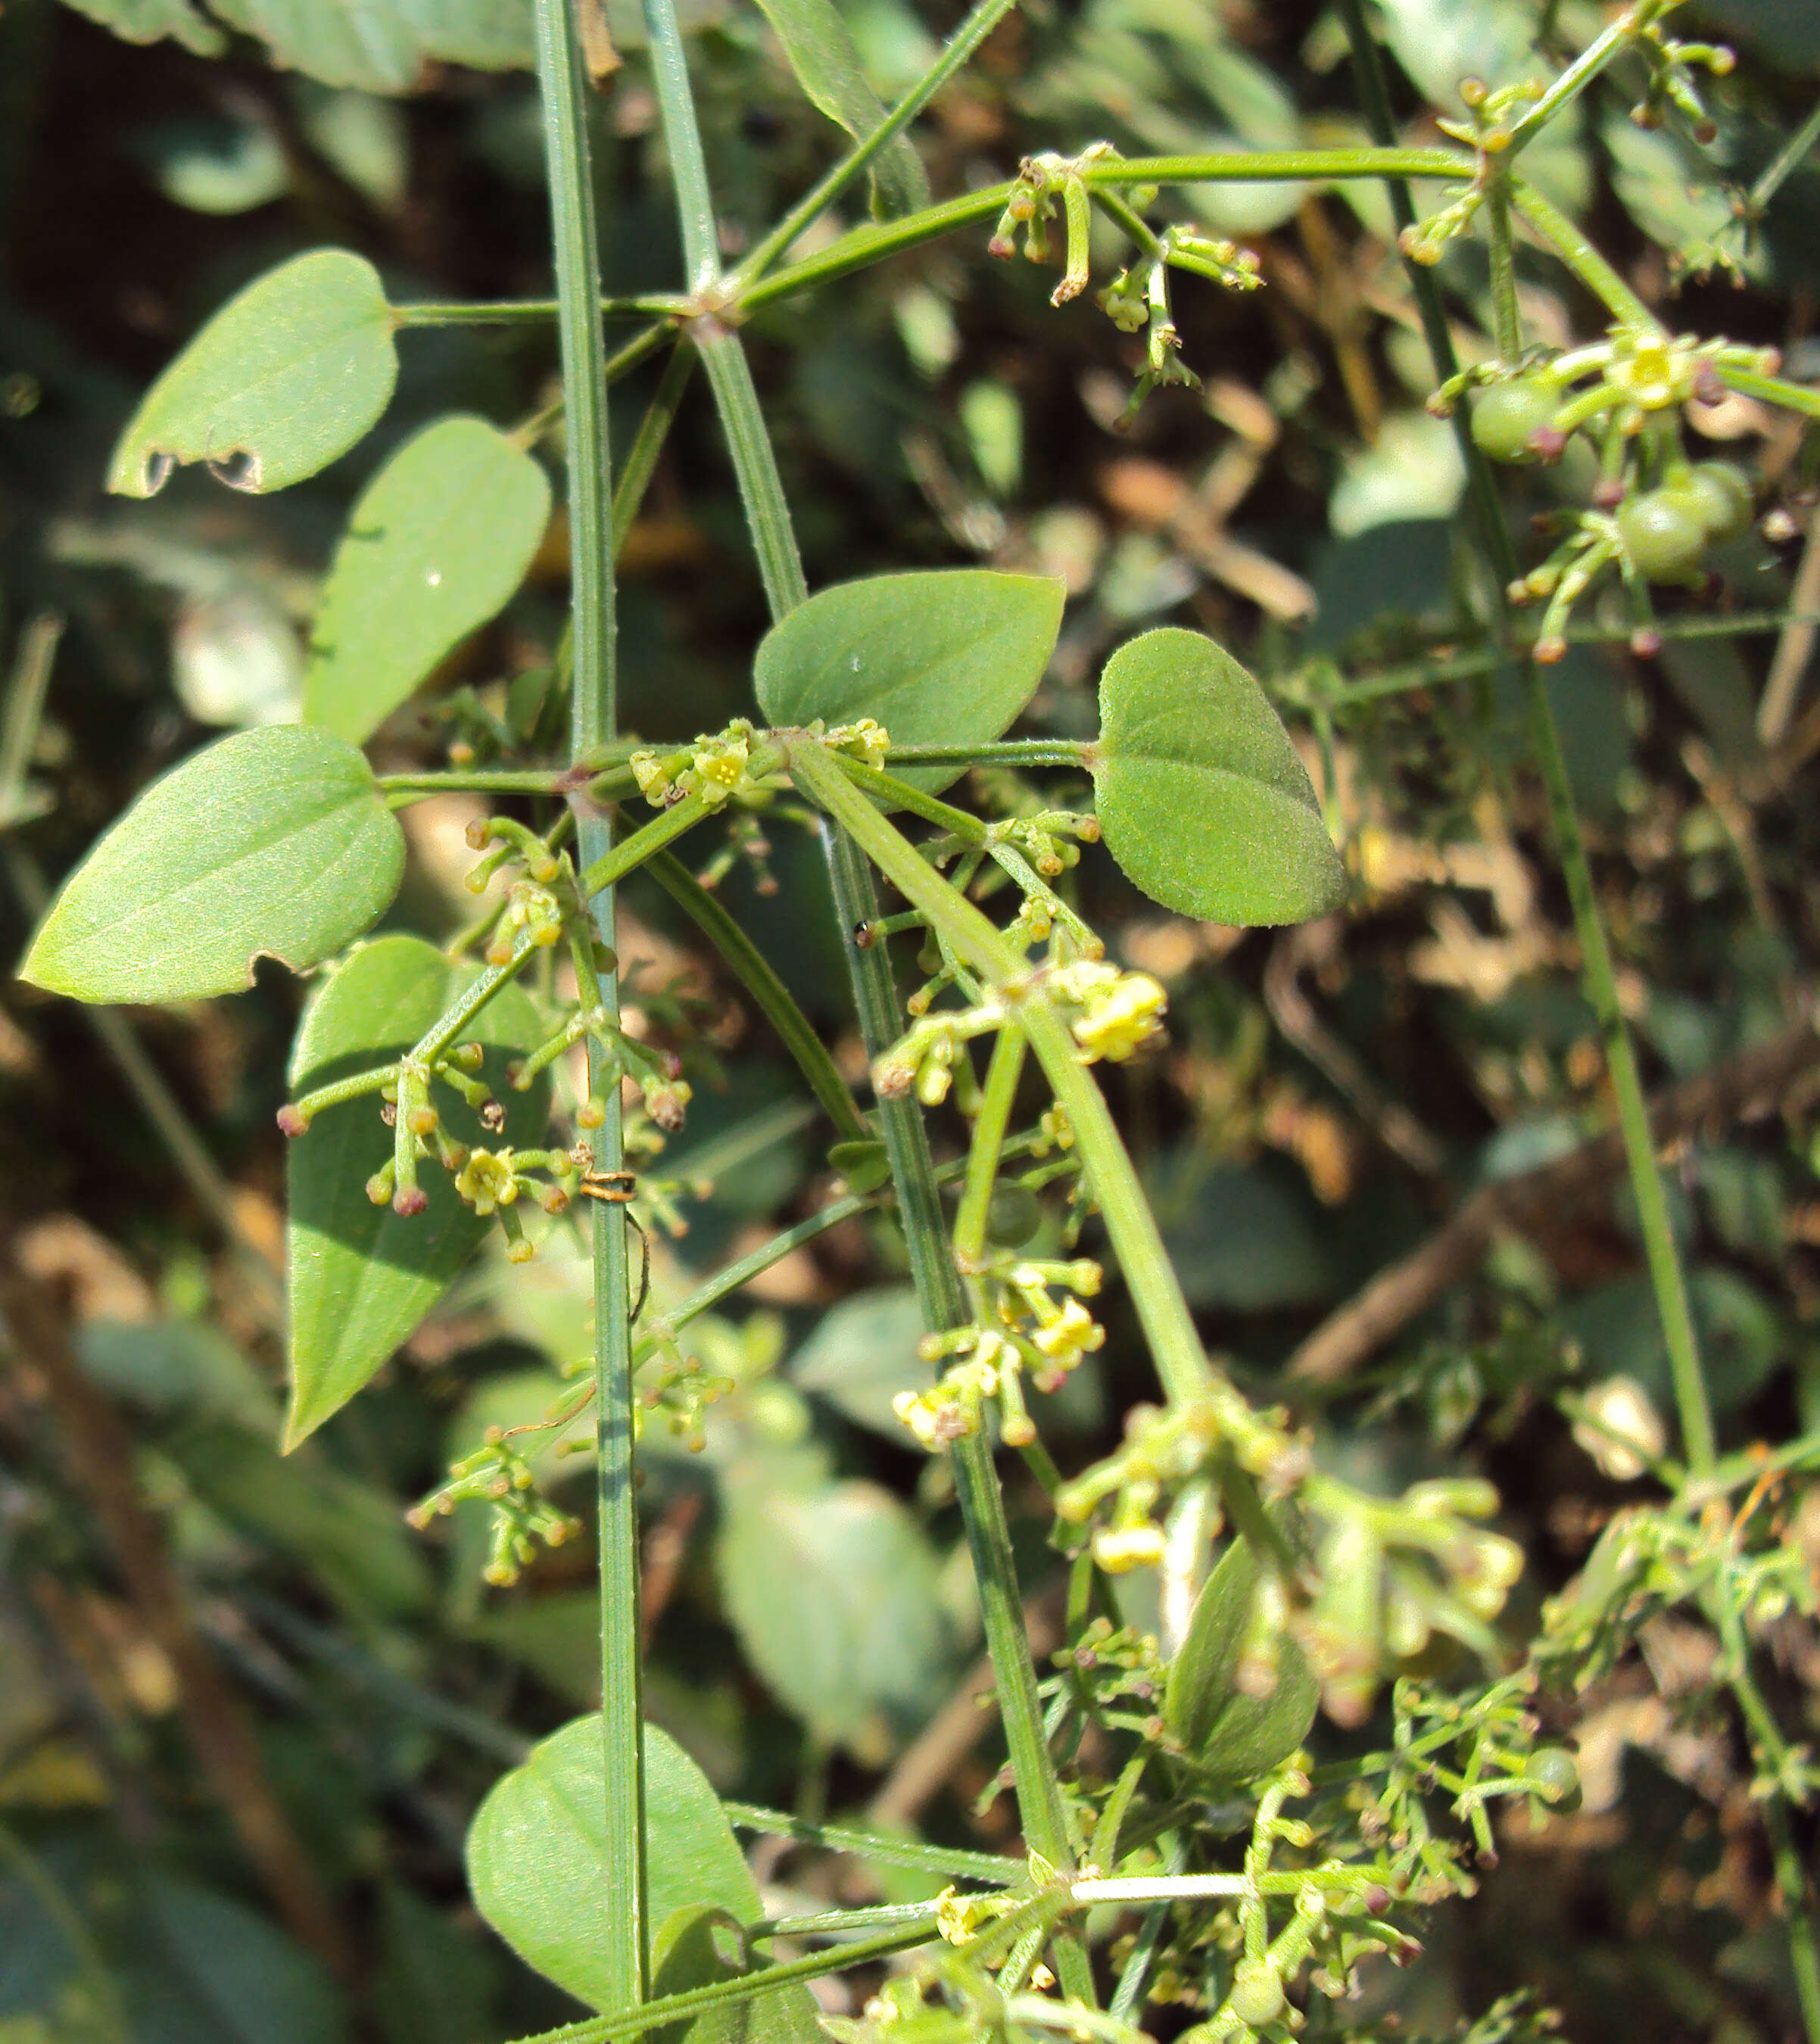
(1092, 625, 1345, 924)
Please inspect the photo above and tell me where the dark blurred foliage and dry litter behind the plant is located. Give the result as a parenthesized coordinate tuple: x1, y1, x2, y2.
(11, 0, 1820, 2044)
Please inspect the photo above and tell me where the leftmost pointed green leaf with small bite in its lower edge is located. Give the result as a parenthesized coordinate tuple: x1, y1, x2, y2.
(18, 724, 405, 1002)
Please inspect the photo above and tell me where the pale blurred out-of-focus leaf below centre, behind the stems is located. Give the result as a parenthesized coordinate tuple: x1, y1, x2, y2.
(715, 1460, 953, 1766)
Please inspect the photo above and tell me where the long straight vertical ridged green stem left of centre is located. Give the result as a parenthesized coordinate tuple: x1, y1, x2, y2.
(536, 0, 648, 2009)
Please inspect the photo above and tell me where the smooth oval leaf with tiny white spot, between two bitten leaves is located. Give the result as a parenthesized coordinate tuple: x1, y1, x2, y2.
(303, 417, 550, 744)
